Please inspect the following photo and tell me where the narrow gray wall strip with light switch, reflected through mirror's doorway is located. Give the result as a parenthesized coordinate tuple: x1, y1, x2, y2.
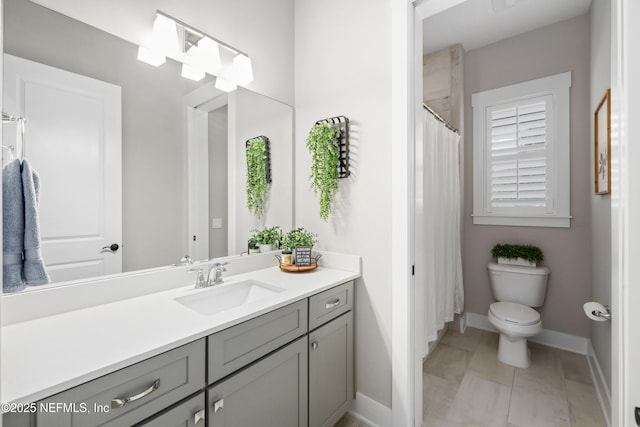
(209, 105, 229, 258)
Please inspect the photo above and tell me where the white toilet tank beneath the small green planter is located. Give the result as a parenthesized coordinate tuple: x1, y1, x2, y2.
(487, 262, 549, 307)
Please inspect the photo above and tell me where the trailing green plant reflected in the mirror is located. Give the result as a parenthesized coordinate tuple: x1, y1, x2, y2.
(247, 137, 269, 219)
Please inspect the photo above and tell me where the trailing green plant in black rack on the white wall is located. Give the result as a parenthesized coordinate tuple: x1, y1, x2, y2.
(307, 122, 340, 221)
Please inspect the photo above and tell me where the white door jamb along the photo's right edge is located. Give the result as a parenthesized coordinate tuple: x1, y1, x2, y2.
(611, 0, 640, 427)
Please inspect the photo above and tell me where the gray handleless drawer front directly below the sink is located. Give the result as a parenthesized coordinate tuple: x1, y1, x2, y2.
(207, 300, 307, 384)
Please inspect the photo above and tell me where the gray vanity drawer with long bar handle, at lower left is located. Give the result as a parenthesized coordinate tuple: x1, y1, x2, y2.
(37, 339, 205, 427)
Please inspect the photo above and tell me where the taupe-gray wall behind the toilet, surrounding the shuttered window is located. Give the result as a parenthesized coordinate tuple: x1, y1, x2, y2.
(464, 15, 592, 337)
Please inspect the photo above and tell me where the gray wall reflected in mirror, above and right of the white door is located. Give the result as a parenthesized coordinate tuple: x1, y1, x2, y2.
(4, 0, 197, 271)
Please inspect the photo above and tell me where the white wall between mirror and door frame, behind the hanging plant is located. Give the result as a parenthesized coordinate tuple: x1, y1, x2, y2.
(295, 0, 393, 407)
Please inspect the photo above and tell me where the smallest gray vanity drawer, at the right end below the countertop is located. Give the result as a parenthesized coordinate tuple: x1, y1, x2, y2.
(309, 281, 353, 330)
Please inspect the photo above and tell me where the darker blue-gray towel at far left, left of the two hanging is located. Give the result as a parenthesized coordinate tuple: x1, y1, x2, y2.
(2, 159, 26, 292)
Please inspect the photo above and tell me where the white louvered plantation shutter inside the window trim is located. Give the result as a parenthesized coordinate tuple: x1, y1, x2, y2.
(486, 96, 552, 212)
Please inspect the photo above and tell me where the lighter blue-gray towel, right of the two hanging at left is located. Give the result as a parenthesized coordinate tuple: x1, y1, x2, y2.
(22, 159, 51, 285)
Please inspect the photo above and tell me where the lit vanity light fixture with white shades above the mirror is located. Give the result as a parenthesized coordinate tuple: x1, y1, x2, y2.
(138, 11, 253, 88)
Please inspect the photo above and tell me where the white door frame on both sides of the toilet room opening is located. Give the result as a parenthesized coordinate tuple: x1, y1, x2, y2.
(390, 0, 640, 427)
